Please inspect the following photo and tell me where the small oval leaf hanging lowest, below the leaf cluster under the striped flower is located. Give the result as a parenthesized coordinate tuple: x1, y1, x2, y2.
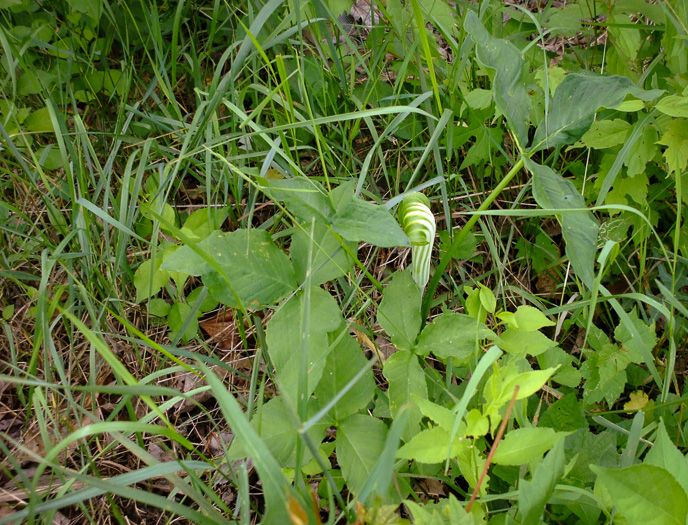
(336, 414, 387, 495)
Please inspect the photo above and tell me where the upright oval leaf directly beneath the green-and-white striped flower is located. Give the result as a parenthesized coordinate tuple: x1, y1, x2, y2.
(377, 270, 422, 350)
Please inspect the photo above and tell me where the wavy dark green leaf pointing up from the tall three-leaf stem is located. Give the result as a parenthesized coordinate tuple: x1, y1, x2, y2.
(464, 10, 530, 147)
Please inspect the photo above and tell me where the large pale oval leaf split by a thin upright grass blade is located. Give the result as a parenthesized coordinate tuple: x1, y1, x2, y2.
(266, 287, 342, 404)
